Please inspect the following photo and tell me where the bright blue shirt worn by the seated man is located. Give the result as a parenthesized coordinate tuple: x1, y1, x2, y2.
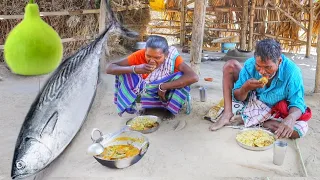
(232, 54, 307, 113)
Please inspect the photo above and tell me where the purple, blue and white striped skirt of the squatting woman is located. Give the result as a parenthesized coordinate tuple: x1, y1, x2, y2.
(114, 72, 190, 116)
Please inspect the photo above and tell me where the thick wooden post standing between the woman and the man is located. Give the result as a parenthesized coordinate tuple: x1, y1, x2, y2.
(190, 0, 207, 75)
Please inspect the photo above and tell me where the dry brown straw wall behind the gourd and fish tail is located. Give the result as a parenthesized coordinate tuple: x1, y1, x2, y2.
(0, 0, 150, 61)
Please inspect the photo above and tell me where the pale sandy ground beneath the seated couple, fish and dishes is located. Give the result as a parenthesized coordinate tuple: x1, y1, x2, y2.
(0, 48, 320, 180)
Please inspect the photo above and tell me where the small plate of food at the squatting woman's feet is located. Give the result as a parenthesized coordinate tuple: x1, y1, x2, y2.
(126, 115, 161, 134)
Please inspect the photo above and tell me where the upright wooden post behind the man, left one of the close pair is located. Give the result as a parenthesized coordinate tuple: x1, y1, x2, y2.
(240, 0, 249, 50)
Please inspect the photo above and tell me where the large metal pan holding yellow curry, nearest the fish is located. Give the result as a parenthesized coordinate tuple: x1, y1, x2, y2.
(93, 128, 149, 169)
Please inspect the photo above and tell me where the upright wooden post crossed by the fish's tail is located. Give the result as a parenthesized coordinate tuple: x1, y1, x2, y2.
(99, 0, 108, 76)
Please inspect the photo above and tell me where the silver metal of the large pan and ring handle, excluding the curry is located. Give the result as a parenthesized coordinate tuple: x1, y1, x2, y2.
(91, 126, 150, 169)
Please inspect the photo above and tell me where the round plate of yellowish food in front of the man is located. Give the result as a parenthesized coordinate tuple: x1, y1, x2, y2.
(236, 128, 276, 151)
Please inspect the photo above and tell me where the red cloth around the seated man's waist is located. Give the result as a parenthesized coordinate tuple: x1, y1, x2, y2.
(271, 100, 312, 121)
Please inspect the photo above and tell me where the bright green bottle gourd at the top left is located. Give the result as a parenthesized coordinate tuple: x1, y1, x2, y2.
(4, 0, 63, 75)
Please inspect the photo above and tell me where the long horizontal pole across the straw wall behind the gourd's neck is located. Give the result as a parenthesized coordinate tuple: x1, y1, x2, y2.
(0, 4, 148, 20)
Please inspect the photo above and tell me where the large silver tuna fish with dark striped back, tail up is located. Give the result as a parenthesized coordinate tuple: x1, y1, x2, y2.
(11, 0, 137, 179)
